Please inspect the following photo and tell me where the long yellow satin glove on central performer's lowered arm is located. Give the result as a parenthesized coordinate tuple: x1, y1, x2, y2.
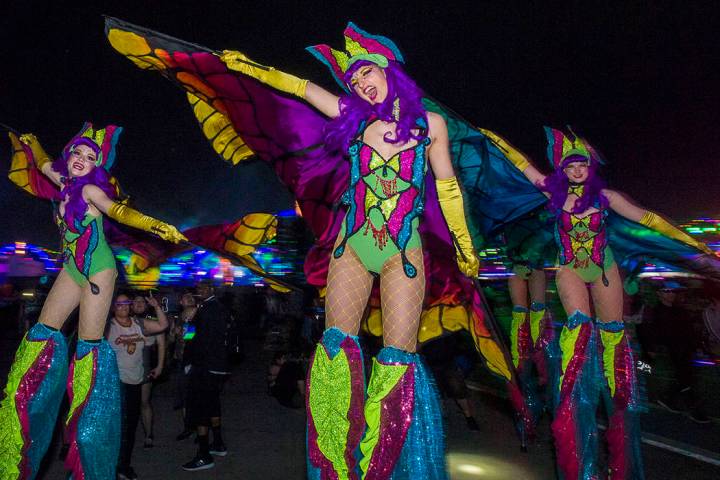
(435, 177, 480, 278)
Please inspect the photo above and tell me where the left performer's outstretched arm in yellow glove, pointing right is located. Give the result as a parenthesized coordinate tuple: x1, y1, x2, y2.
(83, 185, 187, 243)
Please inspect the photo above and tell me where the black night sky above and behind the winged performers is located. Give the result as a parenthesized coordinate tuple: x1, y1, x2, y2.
(0, 0, 720, 247)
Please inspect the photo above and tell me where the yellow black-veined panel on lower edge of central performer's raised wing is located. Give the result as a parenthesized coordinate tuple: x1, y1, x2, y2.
(187, 93, 254, 165)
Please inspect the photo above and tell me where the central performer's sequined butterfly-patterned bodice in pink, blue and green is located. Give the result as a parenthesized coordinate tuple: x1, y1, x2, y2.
(334, 120, 430, 277)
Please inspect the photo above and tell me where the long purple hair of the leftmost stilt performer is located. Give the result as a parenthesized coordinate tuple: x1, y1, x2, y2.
(52, 147, 117, 231)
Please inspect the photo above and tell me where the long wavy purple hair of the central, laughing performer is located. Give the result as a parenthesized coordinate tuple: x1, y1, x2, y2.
(325, 60, 427, 151)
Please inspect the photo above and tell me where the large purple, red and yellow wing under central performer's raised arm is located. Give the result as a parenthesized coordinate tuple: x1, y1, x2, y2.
(105, 18, 348, 287)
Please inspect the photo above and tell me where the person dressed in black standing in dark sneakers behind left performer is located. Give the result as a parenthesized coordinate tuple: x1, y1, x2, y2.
(182, 282, 230, 471)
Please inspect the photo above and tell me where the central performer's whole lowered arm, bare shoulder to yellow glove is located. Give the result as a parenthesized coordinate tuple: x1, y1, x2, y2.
(428, 113, 480, 278)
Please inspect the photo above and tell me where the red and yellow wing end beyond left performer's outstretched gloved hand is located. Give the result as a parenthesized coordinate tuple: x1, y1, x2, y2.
(183, 213, 297, 291)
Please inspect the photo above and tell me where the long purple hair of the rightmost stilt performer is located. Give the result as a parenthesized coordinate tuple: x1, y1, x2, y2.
(540, 155, 608, 214)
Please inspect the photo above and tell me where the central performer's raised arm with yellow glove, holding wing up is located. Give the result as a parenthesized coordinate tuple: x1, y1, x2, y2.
(220, 50, 340, 118)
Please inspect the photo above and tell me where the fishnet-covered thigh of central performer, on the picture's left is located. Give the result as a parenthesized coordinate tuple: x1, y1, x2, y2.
(325, 245, 374, 335)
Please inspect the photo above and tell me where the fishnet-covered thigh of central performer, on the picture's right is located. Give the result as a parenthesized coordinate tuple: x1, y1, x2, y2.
(380, 248, 425, 352)
